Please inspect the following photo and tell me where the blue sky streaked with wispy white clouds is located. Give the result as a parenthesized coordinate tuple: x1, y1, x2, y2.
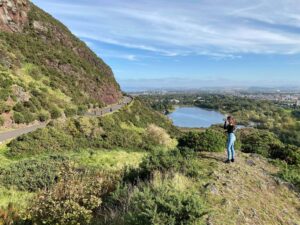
(33, 0, 300, 89)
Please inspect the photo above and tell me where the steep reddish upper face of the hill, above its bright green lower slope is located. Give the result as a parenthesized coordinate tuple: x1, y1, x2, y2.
(0, 0, 121, 105)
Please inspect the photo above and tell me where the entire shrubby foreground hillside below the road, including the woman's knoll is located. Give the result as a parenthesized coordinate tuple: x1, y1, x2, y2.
(0, 100, 300, 225)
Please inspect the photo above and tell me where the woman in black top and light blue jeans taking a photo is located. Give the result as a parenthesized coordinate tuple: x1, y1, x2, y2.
(224, 116, 236, 163)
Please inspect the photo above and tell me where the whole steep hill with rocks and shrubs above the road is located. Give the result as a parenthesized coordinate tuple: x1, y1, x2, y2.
(0, 0, 122, 127)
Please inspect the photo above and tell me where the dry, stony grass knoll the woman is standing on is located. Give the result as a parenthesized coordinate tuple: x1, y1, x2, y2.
(199, 153, 300, 225)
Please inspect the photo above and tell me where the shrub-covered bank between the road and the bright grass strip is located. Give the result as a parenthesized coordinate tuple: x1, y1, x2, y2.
(8, 100, 177, 158)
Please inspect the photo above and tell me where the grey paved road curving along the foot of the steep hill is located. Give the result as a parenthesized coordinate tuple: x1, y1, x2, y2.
(0, 96, 133, 143)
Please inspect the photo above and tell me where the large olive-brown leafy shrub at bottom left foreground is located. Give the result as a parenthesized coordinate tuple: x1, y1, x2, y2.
(29, 176, 107, 225)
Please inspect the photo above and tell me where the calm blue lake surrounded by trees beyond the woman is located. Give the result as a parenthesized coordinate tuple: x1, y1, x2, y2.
(168, 107, 225, 128)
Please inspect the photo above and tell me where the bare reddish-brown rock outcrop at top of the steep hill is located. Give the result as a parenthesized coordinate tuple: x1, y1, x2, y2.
(0, 0, 29, 32)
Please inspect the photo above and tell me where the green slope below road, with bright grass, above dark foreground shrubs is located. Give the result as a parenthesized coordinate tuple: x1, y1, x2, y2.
(0, 100, 178, 224)
